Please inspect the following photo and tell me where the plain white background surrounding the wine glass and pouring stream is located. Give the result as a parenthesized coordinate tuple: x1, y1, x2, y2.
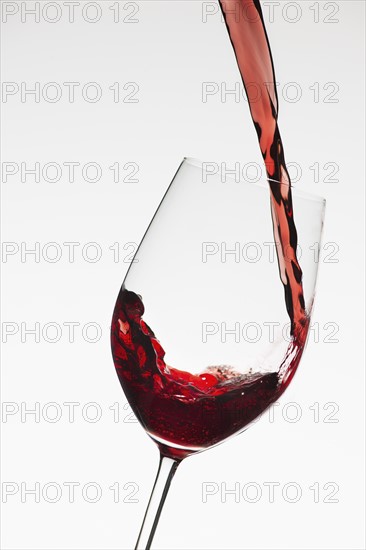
(1, 0, 365, 550)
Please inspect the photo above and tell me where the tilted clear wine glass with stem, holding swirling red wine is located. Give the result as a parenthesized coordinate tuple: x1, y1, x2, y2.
(111, 158, 325, 549)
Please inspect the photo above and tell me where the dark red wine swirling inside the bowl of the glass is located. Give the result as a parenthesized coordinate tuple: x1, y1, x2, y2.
(111, 287, 307, 459)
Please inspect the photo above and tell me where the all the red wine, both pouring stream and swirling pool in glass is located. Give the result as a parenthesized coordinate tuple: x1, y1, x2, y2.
(111, 0, 309, 459)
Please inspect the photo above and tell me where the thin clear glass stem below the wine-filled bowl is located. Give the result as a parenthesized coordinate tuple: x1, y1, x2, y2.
(135, 455, 180, 550)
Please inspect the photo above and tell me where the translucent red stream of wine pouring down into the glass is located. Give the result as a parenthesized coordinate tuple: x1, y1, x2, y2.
(219, 0, 307, 333)
